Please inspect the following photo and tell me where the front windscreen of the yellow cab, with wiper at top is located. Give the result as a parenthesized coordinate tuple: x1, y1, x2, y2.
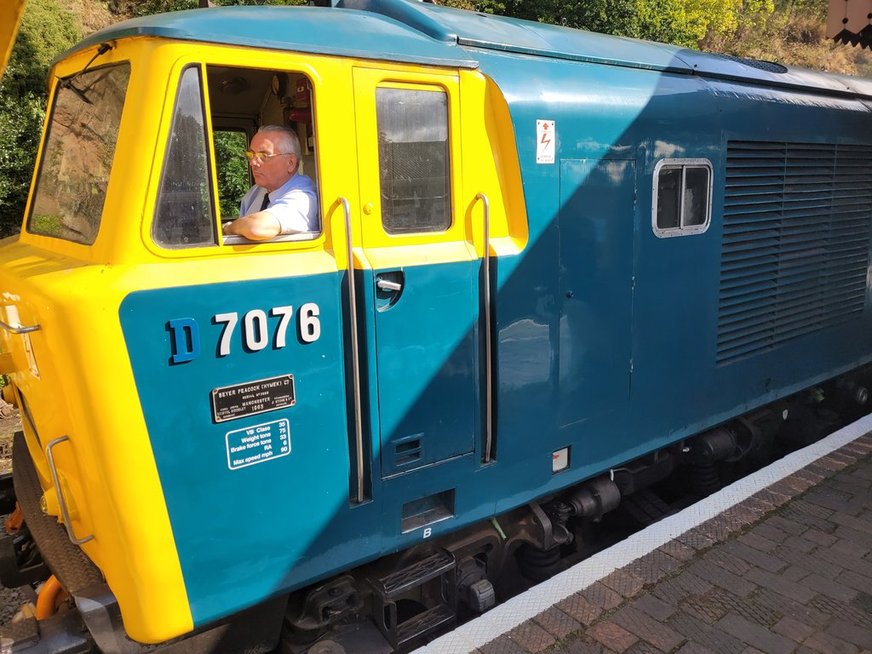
(27, 64, 130, 245)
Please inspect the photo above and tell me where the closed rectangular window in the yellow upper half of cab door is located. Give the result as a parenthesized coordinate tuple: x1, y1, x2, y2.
(376, 87, 451, 234)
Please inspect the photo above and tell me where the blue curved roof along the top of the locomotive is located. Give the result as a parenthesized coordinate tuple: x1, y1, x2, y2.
(76, 0, 872, 98)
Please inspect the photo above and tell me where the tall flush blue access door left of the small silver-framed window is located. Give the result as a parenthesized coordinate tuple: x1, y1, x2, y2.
(557, 159, 636, 461)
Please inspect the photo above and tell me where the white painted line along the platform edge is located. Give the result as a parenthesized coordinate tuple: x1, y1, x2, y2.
(414, 415, 872, 654)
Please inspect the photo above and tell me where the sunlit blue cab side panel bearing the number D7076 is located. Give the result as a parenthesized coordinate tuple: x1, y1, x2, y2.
(120, 275, 364, 624)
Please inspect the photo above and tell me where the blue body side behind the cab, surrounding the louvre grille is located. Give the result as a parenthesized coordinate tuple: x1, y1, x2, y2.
(478, 51, 872, 492)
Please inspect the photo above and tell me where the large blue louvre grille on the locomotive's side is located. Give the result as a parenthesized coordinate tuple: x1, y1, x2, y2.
(717, 141, 872, 365)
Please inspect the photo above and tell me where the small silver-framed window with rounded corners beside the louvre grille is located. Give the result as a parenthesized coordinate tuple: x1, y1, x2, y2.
(652, 159, 712, 238)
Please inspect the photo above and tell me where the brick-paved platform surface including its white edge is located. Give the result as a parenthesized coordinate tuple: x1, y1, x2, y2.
(419, 416, 872, 654)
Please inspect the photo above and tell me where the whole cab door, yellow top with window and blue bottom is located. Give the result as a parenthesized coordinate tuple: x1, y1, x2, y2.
(354, 68, 481, 477)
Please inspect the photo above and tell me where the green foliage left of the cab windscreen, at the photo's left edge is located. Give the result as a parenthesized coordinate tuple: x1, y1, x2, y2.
(0, 0, 82, 237)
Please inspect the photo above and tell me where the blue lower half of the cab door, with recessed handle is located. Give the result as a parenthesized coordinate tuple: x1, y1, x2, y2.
(366, 261, 481, 477)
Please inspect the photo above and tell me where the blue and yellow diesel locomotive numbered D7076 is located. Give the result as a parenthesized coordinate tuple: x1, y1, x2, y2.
(0, 0, 872, 654)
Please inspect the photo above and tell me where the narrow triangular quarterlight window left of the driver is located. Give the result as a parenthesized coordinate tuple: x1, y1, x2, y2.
(152, 66, 216, 248)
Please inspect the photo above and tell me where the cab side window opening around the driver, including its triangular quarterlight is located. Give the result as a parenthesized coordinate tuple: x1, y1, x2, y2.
(152, 65, 319, 249)
